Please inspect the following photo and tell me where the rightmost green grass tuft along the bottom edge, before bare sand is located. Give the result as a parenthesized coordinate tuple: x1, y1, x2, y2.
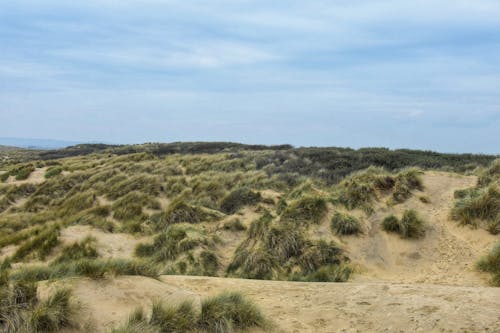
(199, 292, 268, 333)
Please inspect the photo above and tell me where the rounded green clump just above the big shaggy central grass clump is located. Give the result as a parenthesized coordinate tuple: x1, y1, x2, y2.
(281, 197, 327, 223)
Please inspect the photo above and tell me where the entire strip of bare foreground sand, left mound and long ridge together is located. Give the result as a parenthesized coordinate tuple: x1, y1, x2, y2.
(40, 276, 500, 332)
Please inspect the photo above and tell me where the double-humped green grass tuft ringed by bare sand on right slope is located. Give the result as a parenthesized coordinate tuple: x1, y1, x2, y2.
(382, 209, 425, 238)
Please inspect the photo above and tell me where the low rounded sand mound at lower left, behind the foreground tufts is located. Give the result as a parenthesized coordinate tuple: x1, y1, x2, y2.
(39, 276, 199, 333)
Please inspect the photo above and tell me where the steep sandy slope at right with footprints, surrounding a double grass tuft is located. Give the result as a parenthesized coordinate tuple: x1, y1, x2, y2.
(341, 172, 499, 286)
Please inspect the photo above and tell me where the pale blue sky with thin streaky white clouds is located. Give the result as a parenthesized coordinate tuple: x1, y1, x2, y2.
(0, 0, 500, 154)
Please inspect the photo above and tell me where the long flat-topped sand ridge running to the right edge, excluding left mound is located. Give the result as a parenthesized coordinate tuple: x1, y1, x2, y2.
(162, 276, 500, 332)
